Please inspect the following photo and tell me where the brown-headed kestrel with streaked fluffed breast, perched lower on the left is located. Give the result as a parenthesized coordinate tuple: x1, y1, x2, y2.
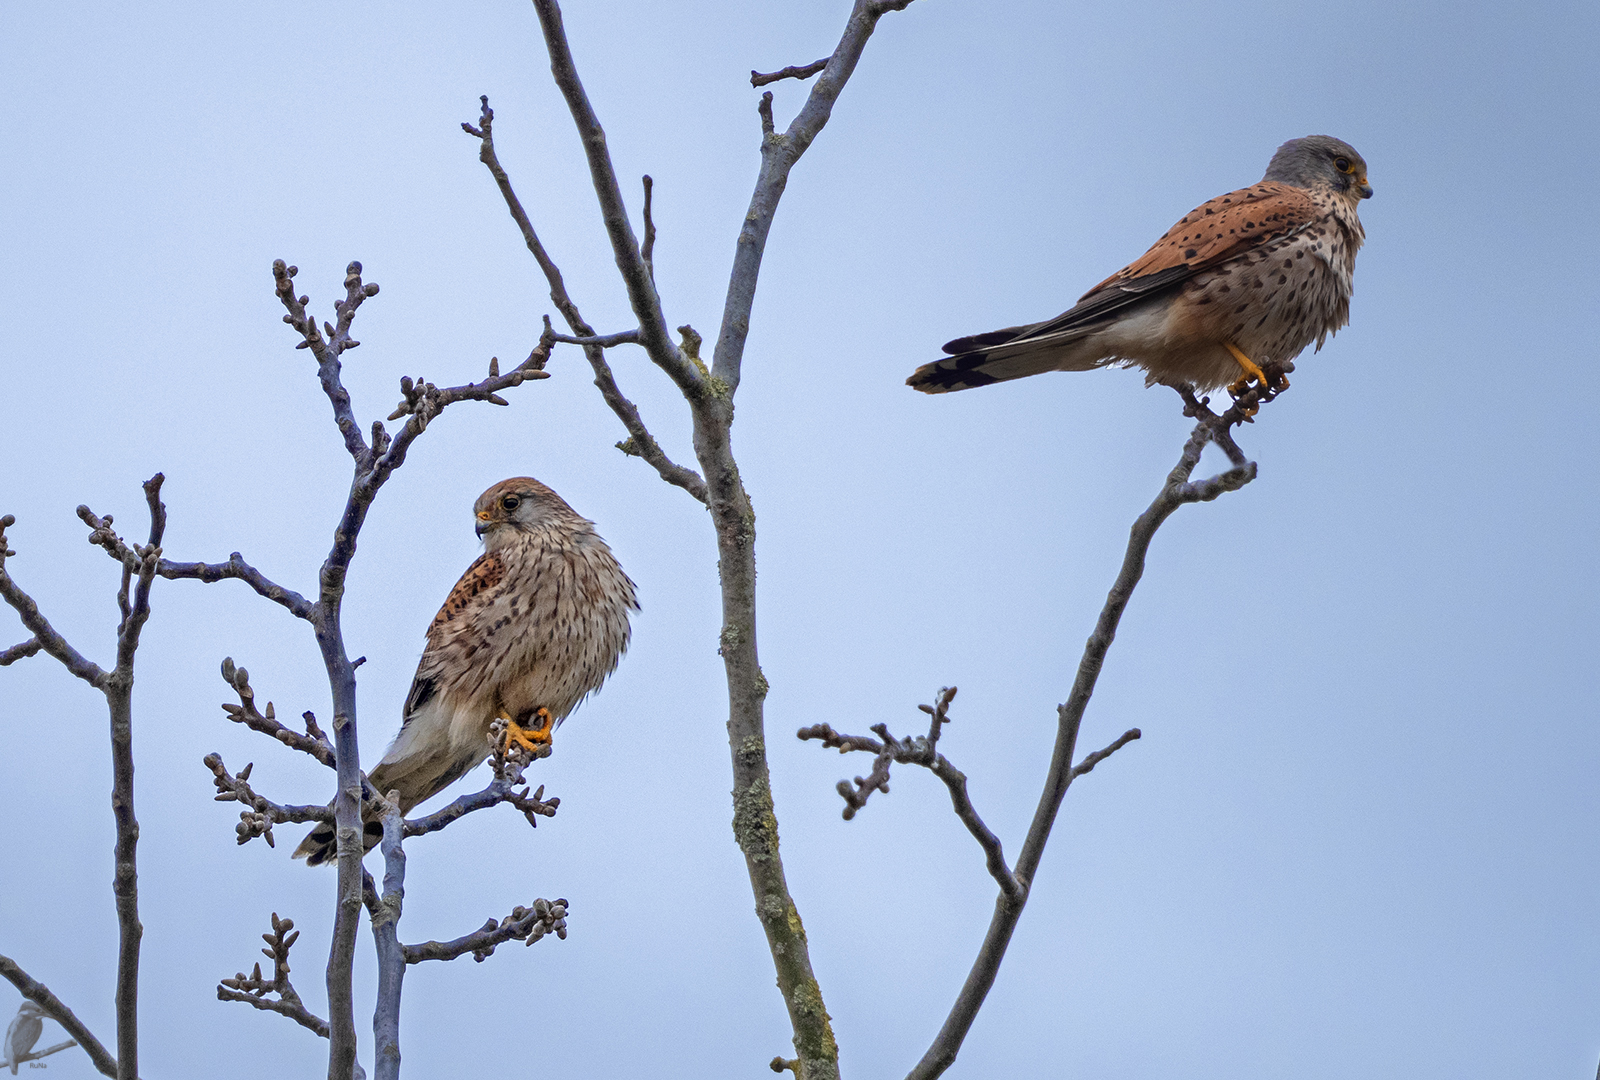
(294, 477, 638, 866)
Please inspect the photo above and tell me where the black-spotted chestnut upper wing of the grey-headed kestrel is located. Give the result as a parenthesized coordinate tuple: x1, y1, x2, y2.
(1080, 181, 1325, 302)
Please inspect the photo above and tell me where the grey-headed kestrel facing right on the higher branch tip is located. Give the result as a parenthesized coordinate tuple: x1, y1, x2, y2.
(906, 134, 1373, 394)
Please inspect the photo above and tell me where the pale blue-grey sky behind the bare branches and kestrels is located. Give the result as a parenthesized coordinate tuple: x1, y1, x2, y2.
(0, 0, 1600, 1080)
